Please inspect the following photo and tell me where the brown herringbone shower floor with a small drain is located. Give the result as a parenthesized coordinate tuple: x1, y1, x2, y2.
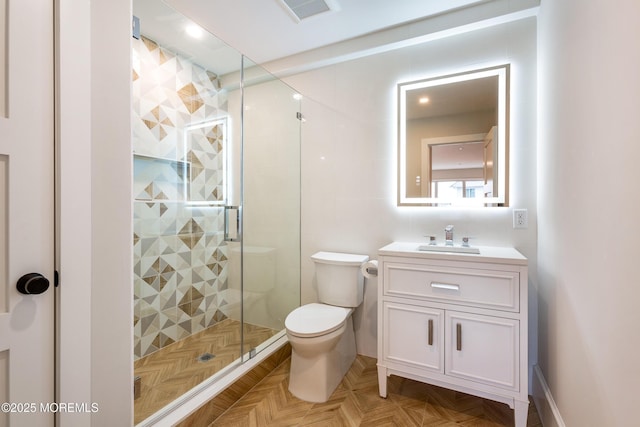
(133, 319, 278, 424)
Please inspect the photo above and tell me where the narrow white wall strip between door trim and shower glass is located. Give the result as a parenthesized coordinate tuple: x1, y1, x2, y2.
(90, 0, 133, 427)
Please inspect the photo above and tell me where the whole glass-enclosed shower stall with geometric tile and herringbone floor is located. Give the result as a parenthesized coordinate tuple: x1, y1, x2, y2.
(132, 0, 301, 425)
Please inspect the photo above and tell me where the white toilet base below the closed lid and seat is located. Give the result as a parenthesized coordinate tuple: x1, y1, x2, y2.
(289, 316, 356, 403)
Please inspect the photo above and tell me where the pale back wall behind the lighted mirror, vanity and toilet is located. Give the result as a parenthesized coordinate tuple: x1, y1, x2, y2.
(285, 18, 536, 360)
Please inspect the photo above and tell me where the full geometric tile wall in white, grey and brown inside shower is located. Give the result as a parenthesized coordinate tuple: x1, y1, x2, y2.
(132, 37, 228, 359)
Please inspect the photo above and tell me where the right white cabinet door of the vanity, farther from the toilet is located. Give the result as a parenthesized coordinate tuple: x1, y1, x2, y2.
(445, 311, 519, 390)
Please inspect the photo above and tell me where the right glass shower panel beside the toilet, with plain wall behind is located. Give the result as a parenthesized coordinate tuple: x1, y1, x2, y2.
(242, 59, 302, 353)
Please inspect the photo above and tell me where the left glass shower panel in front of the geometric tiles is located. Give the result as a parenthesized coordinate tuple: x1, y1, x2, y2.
(132, 0, 242, 424)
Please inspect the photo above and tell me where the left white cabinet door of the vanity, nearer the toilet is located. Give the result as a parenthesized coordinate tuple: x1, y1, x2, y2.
(383, 302, 444, 372)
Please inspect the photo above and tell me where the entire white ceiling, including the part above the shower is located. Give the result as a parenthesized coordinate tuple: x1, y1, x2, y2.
(133, 0, 496, 74)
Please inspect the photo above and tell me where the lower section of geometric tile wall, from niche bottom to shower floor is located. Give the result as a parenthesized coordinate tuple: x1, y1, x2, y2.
(134, 201, 227, 357)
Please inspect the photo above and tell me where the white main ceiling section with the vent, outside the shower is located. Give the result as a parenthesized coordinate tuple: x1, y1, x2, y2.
(162, 0, 488, 63)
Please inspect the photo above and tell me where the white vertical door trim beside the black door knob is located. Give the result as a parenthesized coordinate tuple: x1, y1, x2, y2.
(56, 0, 92, 427)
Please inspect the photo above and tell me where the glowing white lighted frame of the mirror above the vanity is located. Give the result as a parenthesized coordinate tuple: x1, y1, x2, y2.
(397, 64, 510, 207)
